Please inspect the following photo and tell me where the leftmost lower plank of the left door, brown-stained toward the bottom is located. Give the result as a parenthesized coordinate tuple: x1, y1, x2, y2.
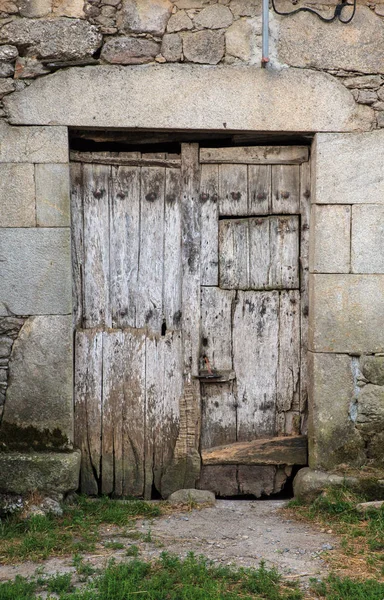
(74, 329, 103, 495)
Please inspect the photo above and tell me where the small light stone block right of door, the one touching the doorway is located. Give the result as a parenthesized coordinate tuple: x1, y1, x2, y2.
(309, 204, 351, 273)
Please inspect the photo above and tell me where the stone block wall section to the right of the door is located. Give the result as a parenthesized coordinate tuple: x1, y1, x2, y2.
(309, 132, 384, 469)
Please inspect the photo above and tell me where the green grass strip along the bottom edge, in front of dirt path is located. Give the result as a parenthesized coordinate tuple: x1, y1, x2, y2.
(0, 553, 303, 600)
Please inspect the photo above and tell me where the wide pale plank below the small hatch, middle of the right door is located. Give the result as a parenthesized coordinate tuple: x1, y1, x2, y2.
(233, 291, 279, 441)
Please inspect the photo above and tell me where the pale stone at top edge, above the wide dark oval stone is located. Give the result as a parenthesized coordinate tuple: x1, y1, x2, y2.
(117, 0, 173, 35)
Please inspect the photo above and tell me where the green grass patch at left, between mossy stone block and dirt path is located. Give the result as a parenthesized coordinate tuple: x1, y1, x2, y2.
(0, 496, 160, 563)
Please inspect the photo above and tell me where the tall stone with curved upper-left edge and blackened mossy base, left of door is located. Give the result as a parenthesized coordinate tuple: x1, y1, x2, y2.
(0, 315, 73, 450)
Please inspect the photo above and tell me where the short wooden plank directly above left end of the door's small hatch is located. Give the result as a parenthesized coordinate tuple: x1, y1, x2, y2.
(219, 164, 248, 216)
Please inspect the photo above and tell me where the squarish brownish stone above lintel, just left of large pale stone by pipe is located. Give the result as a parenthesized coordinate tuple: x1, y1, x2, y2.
(183, 29, 224, 65)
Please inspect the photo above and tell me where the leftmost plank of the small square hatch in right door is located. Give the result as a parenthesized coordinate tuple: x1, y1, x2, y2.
(219, 219, 249, 290)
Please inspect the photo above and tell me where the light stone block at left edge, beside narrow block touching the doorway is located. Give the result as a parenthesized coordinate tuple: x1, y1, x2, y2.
(0, 163, 36, 227)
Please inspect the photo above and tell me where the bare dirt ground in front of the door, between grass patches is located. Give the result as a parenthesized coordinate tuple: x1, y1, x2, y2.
(0, 500, 338, 584)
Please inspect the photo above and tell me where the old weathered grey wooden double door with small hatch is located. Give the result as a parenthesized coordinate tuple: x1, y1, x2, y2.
(72, 144, 309, 498)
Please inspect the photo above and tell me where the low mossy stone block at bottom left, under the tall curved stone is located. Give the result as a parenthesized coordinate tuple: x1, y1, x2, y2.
(0, 451, 81, 494)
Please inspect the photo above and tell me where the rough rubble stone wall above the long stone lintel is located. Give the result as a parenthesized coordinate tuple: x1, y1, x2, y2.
(0, 0, 384, 127)
